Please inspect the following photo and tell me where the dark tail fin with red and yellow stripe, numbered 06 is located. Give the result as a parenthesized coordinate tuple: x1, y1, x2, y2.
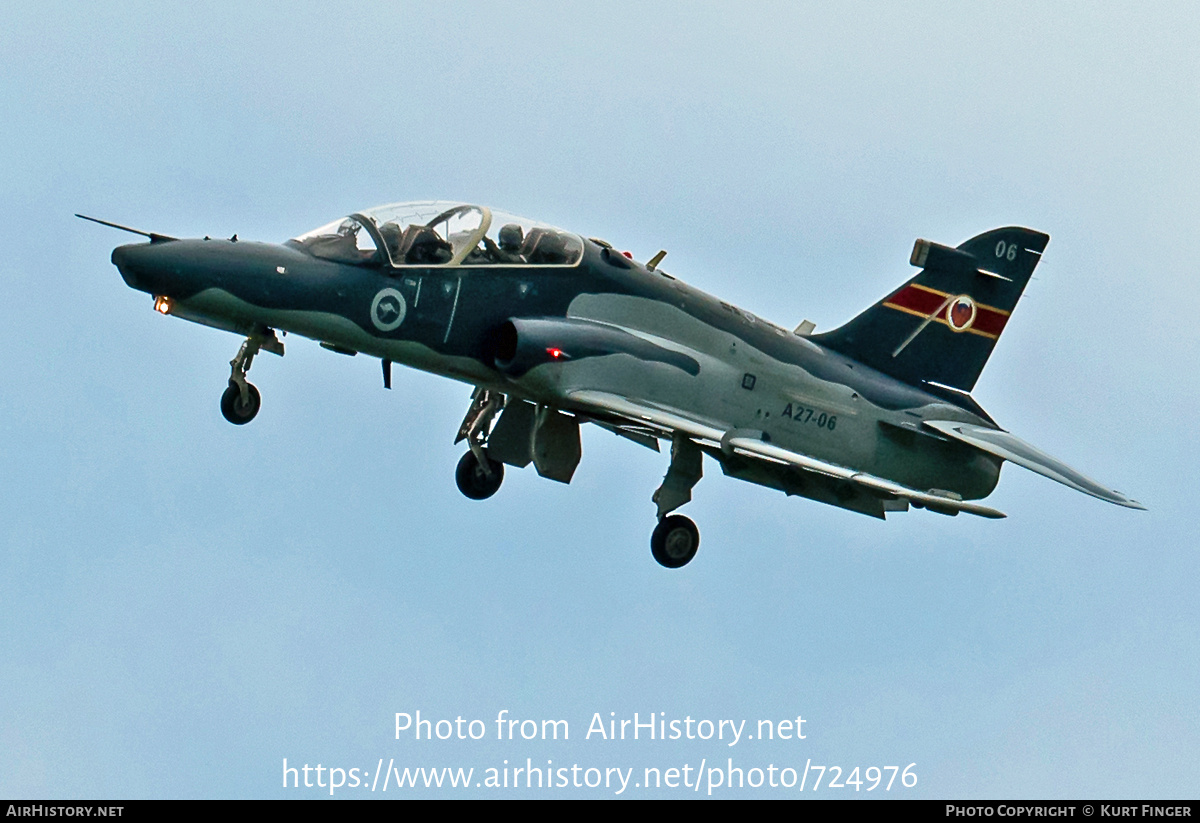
(810, 226, 1050, 391)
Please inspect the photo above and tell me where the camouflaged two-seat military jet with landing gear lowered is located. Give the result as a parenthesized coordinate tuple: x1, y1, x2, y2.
(79, 202, 1142, 567)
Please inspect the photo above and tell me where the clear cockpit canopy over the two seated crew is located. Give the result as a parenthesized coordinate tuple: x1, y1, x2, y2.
(288, 200, 583, 268)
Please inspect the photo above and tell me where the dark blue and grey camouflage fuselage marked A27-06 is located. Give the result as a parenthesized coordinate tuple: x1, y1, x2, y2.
(113, 232, 1001, 516)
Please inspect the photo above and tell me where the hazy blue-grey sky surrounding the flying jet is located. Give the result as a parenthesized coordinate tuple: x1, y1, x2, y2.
(0, 2, 1200, 798)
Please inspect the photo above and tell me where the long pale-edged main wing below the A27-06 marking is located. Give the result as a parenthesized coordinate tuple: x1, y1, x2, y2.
(568, 391, 1006, 518)
